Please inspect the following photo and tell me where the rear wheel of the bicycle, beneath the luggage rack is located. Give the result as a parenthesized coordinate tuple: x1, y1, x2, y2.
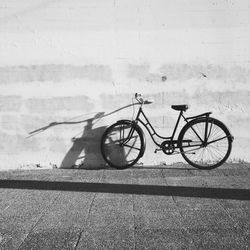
(179, 118, 232, 169)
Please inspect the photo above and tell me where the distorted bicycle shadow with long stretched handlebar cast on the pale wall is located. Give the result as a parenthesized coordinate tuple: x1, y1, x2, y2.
(27, 104, 137, 169)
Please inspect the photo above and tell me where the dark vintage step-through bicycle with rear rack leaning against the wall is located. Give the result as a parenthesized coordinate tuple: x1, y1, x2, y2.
(101, 93, 234, 169)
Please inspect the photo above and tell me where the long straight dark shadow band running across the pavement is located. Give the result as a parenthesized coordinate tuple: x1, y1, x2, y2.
(0, 180, 250, 200)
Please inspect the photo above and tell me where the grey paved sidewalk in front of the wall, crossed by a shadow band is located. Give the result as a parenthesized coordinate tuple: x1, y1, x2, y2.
(0, 164, 250, 250)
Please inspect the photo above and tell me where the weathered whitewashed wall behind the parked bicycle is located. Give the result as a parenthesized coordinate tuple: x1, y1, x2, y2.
(0, 0, 250, 169)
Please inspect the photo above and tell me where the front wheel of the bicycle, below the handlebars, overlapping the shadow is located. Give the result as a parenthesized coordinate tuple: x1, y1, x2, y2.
(101, 121, 145, 169)
